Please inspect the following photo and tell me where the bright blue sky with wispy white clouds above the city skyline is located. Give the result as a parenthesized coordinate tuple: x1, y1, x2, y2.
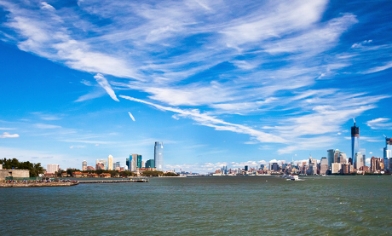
(0, 0, 392, 173)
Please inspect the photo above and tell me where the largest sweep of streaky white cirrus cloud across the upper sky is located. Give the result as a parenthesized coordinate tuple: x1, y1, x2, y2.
(0, 0, 392, 159)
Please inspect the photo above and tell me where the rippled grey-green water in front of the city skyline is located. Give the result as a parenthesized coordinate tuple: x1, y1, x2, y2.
(0, 176, 392, 235)
